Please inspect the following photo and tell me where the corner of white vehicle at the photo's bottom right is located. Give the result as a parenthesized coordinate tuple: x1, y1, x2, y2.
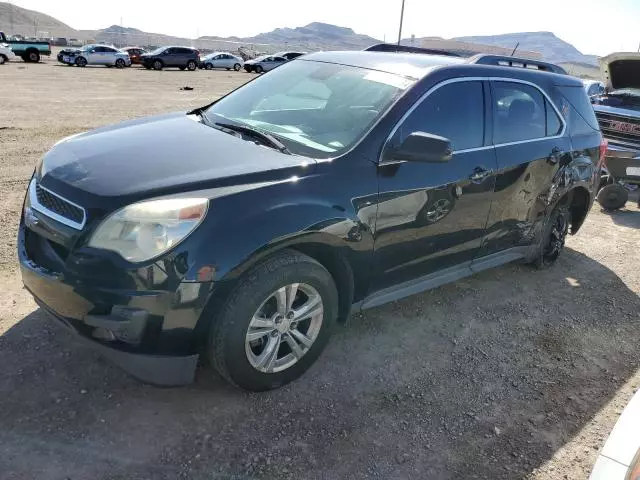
(589, 391, 640, 480)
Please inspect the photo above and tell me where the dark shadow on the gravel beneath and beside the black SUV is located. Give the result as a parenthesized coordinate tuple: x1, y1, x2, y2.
(0, 249, 640, 479)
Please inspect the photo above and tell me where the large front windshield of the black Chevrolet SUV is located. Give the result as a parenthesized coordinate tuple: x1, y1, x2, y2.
(206, 61, 413, 158)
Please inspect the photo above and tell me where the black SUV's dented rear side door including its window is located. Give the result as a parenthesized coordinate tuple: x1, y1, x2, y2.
(481, 79, 572, 256)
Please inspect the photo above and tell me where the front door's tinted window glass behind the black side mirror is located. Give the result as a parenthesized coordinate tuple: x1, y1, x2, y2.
(398, 82, 484, 150)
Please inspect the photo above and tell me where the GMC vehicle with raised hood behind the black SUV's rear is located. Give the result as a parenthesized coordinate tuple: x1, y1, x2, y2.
(591, 53, 640, 210)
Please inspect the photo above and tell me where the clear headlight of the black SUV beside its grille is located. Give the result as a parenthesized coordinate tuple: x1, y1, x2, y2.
(89, 198, 209, 262)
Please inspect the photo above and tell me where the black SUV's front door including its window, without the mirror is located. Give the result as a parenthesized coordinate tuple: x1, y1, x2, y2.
(370, 79, 496, 292)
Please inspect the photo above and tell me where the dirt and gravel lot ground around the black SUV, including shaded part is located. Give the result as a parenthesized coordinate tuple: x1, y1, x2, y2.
(0, 54, 640, 480)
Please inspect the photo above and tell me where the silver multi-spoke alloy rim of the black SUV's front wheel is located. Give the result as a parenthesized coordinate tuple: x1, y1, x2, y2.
(245, 283, 324, 373)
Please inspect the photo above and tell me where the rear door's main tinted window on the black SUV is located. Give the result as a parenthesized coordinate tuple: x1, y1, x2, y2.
(492, 82, 547, 144)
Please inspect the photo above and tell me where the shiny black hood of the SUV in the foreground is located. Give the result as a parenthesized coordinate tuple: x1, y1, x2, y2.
(37, 113, 315, 206)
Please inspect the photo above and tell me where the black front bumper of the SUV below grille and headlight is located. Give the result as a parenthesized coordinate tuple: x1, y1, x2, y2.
(18, 219, 209, 386)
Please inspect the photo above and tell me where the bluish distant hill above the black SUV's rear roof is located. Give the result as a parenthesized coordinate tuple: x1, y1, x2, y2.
(454, 32, 597, 65)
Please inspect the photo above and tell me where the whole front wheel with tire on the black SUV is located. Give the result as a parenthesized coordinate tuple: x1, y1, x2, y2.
(207, 250, 338, 391)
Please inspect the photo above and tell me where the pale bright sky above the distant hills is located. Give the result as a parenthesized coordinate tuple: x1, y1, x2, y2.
(11, 0, 640, 55)
